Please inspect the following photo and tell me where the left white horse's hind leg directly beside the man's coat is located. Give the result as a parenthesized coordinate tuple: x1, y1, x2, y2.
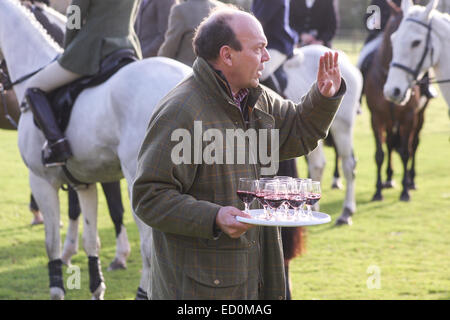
(119, 160, 153, 300)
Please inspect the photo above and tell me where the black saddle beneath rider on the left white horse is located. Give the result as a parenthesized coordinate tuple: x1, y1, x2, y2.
(43, 49, 138, 132)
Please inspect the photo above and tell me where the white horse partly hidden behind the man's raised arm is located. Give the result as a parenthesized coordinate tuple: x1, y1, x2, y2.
(284, 45, 363, 224)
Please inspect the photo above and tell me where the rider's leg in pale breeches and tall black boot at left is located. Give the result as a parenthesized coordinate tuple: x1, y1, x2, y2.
(25, 61, 81, 166)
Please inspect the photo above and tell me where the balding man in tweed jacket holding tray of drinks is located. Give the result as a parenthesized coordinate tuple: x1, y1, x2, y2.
(132, 8, 346, 299)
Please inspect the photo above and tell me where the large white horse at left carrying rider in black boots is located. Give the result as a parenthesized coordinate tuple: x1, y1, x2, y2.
(0, 0, 191, 299)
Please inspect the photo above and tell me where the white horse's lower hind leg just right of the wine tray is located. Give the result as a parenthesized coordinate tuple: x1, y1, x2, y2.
(331, 124, 356, 225)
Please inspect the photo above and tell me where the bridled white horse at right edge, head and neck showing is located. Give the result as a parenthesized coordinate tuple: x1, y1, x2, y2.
(384, 0, 450, 114)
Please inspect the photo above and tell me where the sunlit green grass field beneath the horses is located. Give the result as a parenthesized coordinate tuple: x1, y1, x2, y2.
(0, 43, 450, 300)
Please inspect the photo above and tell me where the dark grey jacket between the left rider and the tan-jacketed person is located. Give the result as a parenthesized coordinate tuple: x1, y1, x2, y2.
(134, 0, 176, 58)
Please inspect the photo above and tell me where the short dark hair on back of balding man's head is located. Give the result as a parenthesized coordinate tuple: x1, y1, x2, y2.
(192, 11, 242, 61)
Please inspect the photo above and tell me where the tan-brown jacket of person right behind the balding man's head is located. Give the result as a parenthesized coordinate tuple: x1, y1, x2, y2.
(158, 0, 224, 67)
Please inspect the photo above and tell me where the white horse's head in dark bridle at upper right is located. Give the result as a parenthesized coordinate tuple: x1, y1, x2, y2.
(384, 0, 440, 104)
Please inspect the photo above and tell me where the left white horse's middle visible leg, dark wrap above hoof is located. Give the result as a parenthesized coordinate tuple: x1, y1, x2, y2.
(77, 183, 106, 300)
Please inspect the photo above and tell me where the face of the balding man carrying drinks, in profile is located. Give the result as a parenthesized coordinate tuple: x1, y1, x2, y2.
(227, 16, 270, 89)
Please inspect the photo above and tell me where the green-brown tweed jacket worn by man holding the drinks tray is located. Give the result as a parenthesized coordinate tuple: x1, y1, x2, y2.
(132, 58, 346, 299)
